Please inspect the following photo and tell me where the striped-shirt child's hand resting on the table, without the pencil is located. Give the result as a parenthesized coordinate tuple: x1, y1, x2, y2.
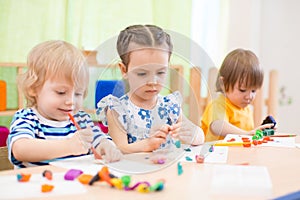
(96, 139, 123, 162)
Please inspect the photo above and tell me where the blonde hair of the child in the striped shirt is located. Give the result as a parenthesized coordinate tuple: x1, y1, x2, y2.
(18, 40, 89, 107)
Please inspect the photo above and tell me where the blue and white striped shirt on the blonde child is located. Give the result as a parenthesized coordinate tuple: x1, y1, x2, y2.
(7, 108, 111, 168)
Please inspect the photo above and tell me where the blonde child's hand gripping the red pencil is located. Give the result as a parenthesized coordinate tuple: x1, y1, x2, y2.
(70, 128, 94, 155)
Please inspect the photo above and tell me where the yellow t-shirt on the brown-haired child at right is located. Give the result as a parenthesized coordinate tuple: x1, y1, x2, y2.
(201, 94, 254, 142)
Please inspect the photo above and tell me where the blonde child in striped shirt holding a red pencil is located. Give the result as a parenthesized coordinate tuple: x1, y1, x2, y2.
(7, 41, 122, 168)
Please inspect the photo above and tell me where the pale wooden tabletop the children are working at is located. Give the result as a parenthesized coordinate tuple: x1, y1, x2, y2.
(0, 136, 300, 200)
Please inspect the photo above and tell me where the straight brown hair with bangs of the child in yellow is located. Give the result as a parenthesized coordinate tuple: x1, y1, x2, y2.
(216, 49, 264, 92)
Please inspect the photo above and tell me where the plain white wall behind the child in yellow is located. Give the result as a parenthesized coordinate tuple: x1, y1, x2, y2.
(224, 0, 300, 133)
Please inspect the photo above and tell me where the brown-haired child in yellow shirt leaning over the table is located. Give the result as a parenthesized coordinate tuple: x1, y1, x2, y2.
(201, 49, 273, 141)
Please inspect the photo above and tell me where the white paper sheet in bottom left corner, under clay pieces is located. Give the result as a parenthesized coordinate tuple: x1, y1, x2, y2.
(0, 173, 86, 200)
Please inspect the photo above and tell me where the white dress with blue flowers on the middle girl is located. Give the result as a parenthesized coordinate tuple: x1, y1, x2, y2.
(96, 91, 182, 147)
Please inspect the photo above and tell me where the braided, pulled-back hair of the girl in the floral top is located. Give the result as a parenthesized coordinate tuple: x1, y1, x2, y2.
(117, 25, 173, 67)
